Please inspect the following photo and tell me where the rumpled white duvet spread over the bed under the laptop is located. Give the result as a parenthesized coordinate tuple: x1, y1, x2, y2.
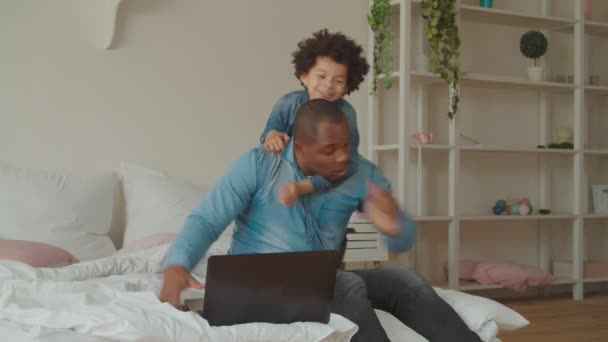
(0, 245, 524, 342)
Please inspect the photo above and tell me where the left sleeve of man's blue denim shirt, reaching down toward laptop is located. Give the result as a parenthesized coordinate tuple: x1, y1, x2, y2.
(165, 150, 258, 270)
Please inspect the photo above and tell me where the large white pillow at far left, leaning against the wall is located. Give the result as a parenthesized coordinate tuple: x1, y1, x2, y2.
(0, 163, 117, 261)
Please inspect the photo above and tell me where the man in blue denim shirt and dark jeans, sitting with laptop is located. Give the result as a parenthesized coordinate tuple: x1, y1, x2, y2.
(161, 99, 480, 341)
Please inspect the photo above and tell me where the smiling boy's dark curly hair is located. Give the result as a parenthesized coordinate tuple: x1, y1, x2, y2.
(292, 29, 369, 95)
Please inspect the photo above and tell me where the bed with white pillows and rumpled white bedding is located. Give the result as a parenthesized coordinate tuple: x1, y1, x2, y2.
(0, 164, 528, 342)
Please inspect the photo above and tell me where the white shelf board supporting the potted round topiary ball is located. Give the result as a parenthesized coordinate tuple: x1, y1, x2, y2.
(410, 71, 575, 92)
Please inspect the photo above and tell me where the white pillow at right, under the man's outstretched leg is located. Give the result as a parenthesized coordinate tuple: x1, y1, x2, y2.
(435, 288, 530, 331)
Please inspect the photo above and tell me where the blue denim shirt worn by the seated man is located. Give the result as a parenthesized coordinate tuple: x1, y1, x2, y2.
(165, 143, 416, 270)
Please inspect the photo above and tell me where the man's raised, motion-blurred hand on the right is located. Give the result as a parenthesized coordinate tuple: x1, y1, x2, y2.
(364, 182, 400, 235)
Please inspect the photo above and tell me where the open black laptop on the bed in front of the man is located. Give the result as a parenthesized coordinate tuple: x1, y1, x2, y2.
(185, 251, 338, 326)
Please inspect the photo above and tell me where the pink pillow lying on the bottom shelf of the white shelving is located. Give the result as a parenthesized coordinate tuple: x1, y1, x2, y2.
(473, 262, 553, 292)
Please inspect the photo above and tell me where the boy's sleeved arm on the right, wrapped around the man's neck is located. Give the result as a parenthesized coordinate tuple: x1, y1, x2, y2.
(310, 100, 359, 192)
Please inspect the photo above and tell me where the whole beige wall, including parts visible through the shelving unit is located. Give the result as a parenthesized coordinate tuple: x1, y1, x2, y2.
(0, 0, 605, 286)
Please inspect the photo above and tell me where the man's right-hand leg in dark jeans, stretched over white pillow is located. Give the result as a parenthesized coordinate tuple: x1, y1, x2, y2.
(352, 267, 481, 342)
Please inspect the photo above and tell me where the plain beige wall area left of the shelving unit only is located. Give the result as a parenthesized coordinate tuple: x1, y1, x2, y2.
(0, 0, 368, 184)
